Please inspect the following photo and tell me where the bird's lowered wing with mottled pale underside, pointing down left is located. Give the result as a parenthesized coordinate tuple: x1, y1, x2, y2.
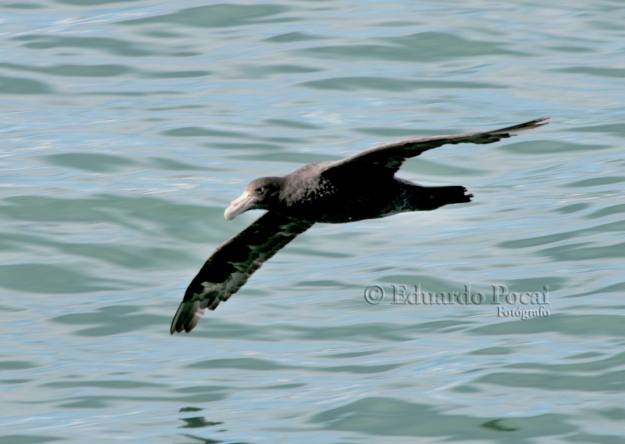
(170, 212, 312, 334)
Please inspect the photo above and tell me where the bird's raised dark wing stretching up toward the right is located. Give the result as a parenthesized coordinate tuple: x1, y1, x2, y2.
(321, 117, 548, 178)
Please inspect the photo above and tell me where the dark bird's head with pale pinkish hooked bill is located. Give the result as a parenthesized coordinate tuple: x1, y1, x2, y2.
(224, 177, 284, 220)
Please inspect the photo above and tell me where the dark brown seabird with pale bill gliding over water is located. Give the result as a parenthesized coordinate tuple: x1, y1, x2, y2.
(170, 117, 549, 334)
